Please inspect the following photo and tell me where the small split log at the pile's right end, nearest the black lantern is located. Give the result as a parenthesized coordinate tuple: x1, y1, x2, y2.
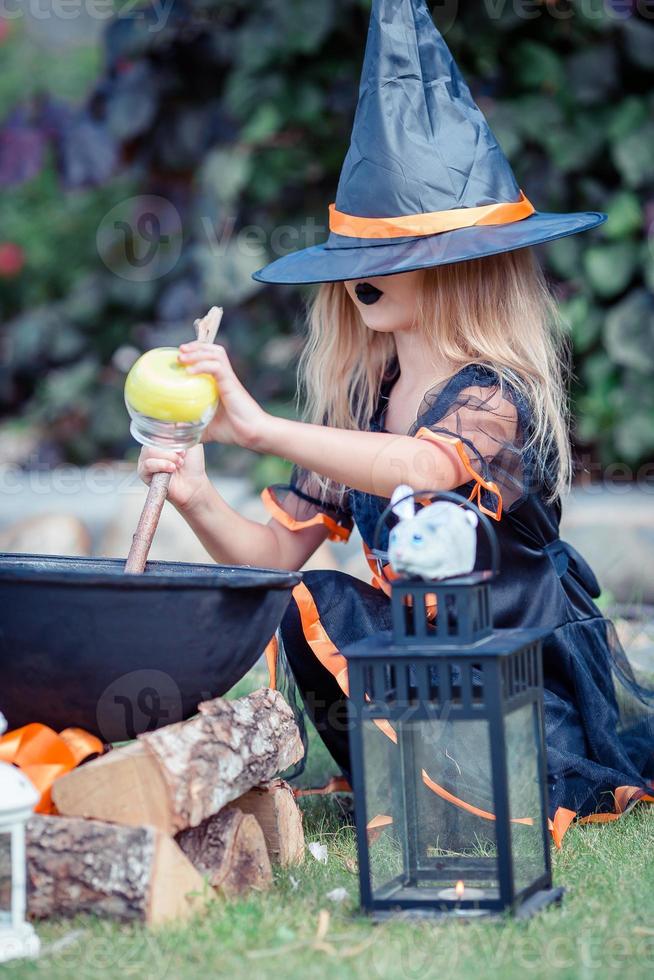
(223, 779, 304, 867)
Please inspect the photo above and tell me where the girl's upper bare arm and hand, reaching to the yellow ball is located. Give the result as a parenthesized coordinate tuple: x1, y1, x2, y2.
(180, 341, 470, 497)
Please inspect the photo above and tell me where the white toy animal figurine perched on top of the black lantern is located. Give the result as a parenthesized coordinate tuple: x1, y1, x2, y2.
(388, 485, 477, 580)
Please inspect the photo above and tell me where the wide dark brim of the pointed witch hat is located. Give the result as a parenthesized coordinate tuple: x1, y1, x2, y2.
(252, 211, 607, 285)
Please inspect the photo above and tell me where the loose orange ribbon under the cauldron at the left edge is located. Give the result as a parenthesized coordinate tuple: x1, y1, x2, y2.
(0, 722, 104, 813)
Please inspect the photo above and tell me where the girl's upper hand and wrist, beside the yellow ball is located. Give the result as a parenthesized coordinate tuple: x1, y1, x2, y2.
(179, 340, 270, 449)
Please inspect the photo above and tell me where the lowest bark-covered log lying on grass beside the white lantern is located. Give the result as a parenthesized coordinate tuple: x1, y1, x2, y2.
(27, 816, 213, 925)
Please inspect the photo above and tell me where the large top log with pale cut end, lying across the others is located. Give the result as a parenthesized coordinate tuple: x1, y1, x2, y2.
(53, 688, 304, 835)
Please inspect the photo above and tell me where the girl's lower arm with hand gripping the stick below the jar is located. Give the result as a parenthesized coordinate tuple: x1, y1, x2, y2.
(138, 446, 327, 570)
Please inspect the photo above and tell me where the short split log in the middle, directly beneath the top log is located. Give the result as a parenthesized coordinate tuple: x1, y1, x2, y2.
(175, 808, 272, 898)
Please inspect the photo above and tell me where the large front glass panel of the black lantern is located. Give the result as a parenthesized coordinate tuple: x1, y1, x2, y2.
(363, 717, 499, 901)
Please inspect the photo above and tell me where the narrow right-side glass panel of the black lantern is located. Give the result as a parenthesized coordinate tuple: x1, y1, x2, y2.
(504, 703, 547, 894)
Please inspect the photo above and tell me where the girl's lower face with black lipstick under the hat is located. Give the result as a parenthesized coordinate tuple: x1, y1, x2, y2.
(345, 270, 423, 333)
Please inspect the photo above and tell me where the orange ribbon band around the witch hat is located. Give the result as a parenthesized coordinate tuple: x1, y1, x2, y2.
(329, 191, 536, 238)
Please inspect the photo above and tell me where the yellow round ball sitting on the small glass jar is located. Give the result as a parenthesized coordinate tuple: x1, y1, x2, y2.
(125, 347, 218, 423)
